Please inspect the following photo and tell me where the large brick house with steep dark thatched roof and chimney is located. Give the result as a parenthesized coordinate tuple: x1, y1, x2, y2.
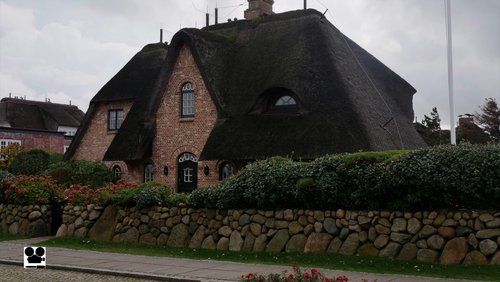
(65, 0, 425, 192)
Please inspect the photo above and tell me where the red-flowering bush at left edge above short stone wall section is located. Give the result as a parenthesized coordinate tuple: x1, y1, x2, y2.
(1, 175, 63, 205)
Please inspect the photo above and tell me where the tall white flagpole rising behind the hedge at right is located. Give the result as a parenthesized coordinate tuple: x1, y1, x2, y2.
(444, 0, 457, 145)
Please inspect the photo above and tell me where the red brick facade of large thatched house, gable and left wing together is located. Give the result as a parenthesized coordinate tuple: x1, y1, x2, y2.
(73, 46, 229, 190)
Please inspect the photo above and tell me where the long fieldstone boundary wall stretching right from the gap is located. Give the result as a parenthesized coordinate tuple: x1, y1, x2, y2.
(58, 205, 500, 264)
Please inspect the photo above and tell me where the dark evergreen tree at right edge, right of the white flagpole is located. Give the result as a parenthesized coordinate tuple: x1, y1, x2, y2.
(475, 98, 500, 142)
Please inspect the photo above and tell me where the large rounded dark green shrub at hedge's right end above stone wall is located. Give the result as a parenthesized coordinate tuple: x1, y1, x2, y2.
(379, 144, 500, 209)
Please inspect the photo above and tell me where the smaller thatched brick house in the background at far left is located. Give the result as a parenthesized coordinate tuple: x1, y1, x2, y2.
(0, 98, 85, 156)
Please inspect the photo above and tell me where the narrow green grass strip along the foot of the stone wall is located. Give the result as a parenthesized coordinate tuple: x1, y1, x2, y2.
(40, 238, 500, 281)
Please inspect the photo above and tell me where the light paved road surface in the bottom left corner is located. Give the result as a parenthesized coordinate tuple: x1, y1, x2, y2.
(0, 264, 154, 282)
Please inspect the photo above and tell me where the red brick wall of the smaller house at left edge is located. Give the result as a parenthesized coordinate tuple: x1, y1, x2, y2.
(0, 129, 65, 153)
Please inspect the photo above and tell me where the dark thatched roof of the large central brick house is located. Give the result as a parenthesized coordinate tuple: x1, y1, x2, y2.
(70, 10, 425, 160)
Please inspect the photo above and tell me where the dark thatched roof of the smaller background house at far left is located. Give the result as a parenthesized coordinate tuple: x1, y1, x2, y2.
(0, 98, 84, 131)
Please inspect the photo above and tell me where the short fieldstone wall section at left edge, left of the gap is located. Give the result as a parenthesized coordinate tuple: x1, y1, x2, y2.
(0, 204, 52, 237)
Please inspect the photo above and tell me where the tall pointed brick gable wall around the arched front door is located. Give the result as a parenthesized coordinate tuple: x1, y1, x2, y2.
(151, 46, 219, 189)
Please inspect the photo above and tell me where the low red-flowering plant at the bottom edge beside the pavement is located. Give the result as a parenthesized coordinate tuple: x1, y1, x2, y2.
(240, 265, 349, 282)
